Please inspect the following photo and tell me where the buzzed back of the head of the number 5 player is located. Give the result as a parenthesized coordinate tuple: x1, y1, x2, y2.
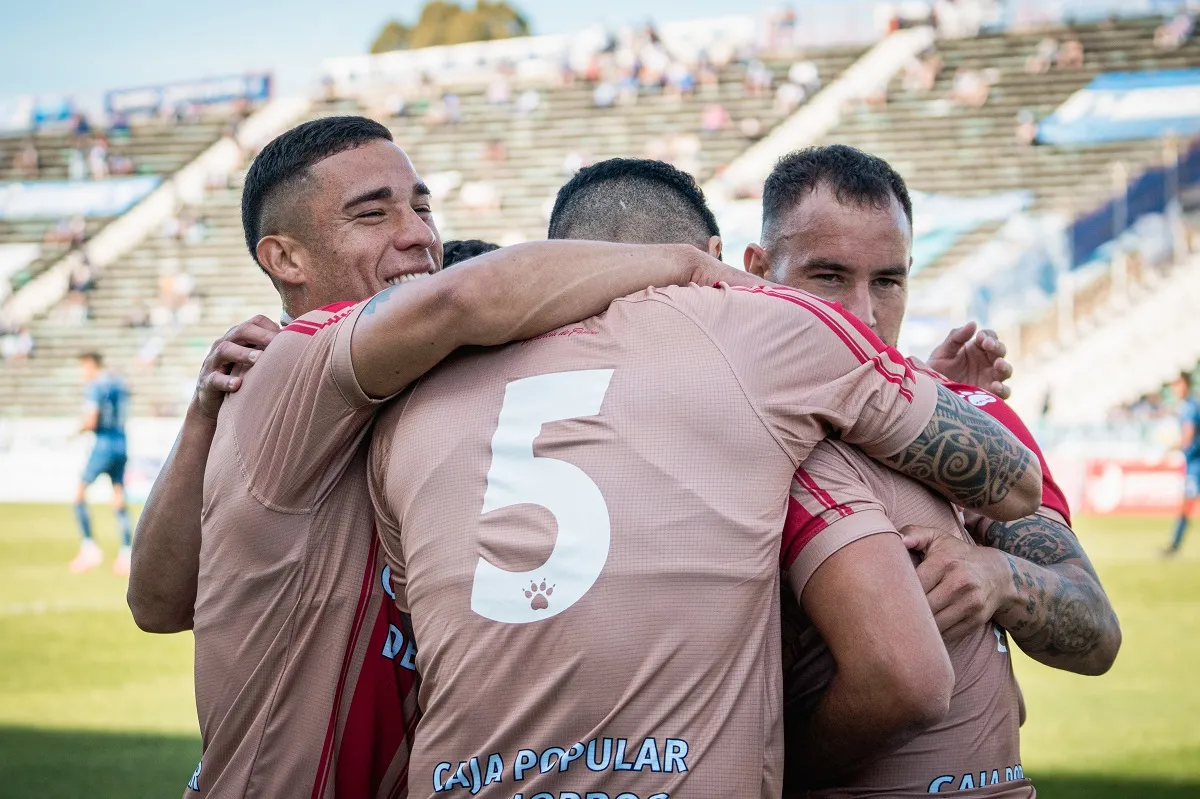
(548, 158, 721, 250)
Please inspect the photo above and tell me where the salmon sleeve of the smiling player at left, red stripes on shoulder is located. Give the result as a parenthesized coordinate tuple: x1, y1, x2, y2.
(221, 298, 378, 513)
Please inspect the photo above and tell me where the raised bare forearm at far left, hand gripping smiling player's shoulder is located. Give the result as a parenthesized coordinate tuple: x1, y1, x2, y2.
(126, 317, 280, 632)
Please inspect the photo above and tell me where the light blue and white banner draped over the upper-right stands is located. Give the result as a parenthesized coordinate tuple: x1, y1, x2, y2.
(1037, 70, 1200, 144)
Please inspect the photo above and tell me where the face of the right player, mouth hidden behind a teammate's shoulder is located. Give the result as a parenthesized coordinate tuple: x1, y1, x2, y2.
(746, 184, 912, 347)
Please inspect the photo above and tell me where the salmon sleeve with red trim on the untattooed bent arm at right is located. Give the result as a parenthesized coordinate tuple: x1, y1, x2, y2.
(779, 441, 899, 597)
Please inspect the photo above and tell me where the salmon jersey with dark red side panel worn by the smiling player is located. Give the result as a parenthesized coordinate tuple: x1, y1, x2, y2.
(194, 304, 416, 799)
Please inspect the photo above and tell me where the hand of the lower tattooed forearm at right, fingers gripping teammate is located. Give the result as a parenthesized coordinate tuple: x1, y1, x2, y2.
(901, 527, 1013, 641)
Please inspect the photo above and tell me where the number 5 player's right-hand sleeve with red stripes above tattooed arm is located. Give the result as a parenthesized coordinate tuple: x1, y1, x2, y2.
(662, 287, 937, 465)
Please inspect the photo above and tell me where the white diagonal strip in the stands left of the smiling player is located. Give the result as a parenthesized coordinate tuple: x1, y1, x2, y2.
(0, 98, 310, 326)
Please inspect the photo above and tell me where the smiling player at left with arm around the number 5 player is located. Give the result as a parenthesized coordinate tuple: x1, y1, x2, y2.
(130, 118, 763, 797)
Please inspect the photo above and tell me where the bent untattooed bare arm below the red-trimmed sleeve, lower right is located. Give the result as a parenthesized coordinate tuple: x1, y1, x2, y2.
(786, 533, 954, 787)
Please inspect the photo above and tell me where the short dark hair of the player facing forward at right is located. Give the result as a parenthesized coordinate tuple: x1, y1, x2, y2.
(762, 144, 912, 246)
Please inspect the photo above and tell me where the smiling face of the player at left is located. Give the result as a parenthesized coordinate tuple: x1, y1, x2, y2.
(258, 139, 442, 317)
